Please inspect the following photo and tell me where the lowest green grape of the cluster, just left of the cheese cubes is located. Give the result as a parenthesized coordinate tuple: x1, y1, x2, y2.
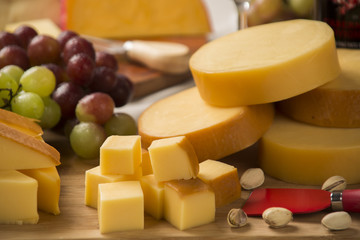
(70, 122, 106, 158)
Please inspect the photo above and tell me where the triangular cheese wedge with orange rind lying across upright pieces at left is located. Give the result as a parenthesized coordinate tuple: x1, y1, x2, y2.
(0, 123, 60, 170)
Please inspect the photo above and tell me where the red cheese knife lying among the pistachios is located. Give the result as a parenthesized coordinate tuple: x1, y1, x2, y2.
(242, 188, 360, 216)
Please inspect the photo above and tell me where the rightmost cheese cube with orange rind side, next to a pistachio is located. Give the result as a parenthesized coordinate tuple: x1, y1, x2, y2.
(198, 159, 241, 207)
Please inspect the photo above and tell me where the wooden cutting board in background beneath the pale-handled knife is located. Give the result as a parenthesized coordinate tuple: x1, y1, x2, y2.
(114, 36, 207, 99)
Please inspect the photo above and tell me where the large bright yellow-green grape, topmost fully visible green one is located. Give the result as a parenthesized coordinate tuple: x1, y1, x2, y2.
(20, 66, 56, 97)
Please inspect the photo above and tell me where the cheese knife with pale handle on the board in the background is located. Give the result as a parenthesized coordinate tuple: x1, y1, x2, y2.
(82, 35, 190, 74)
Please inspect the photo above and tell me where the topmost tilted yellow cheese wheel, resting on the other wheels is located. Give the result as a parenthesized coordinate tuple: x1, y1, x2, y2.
(190, 20, 340, 107)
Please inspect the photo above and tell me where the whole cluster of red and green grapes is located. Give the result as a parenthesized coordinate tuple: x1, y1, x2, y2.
(0, 25, 137, 158)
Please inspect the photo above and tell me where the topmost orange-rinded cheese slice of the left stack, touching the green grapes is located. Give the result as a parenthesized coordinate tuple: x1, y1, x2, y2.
(0, 109, 43, 139)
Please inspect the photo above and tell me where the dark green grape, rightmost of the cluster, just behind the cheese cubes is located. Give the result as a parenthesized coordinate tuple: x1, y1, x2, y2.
(104, 113, 137, 136)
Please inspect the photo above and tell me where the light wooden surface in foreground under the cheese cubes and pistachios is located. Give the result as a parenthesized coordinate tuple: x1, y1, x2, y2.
(0, 134, 360, 240)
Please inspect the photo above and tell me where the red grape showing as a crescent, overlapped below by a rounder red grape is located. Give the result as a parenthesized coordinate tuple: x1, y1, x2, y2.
(62, 37, 95, 64)
